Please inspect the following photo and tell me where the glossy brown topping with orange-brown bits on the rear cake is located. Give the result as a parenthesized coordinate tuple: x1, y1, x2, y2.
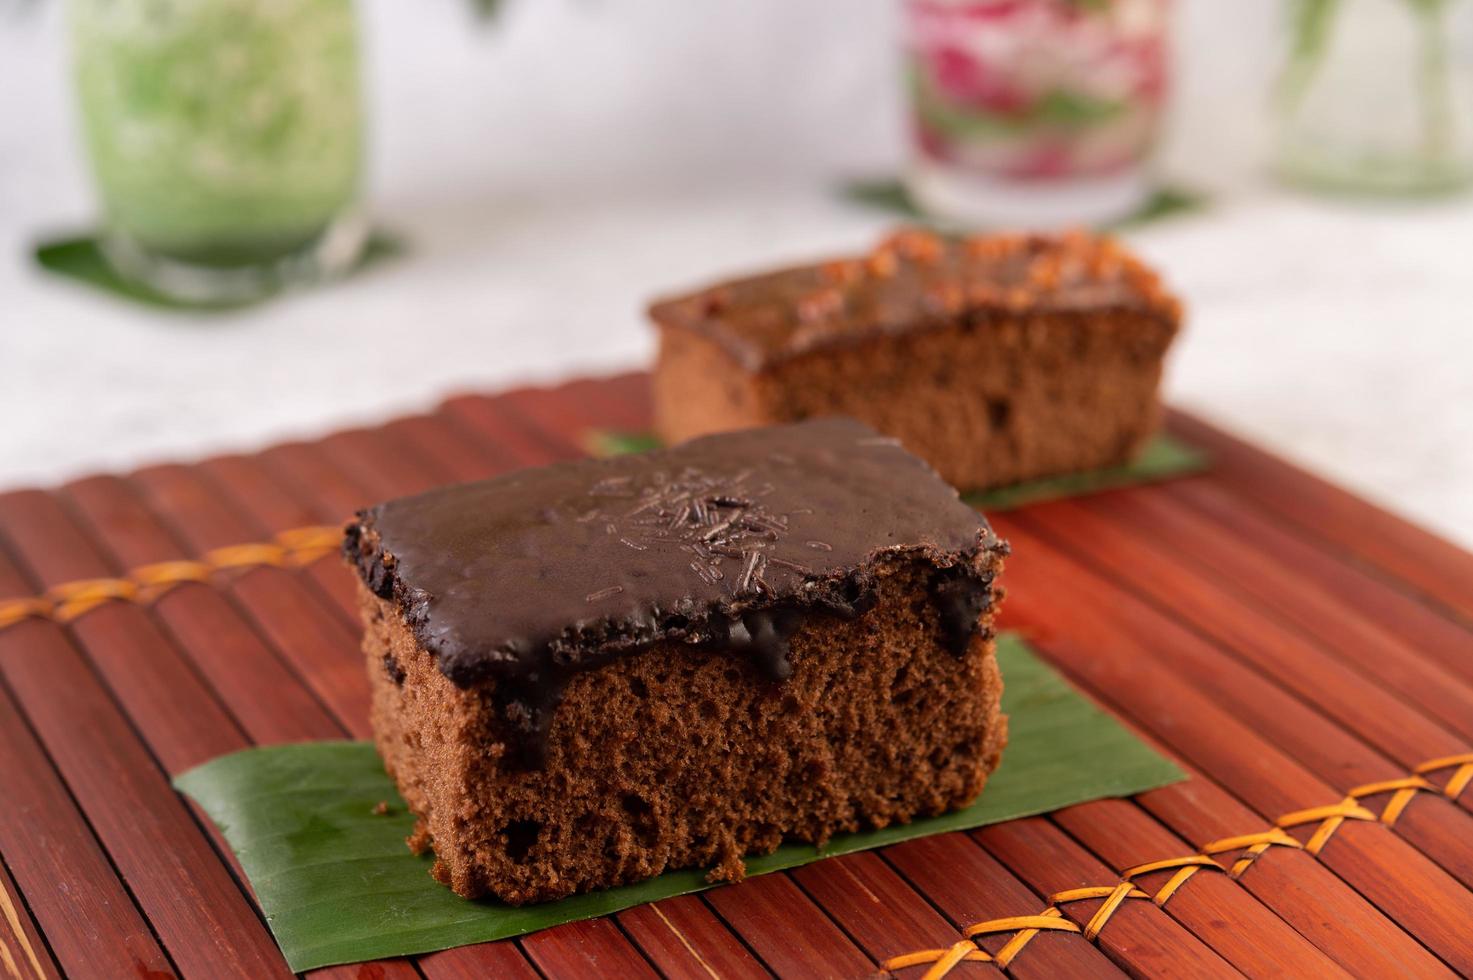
(650, 228, 1180, 370)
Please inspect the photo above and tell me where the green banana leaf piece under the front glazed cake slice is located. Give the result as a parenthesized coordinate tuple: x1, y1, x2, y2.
(174, 634, 1186, 973)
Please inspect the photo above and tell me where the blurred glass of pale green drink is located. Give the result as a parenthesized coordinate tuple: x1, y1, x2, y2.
(71, 0, 367, 301)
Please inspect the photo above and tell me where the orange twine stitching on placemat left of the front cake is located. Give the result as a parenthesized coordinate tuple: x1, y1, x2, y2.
(0, 525, 343, 629)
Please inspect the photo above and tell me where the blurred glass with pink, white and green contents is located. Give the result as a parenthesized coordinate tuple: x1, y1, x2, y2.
(906, 0, 1170, 227)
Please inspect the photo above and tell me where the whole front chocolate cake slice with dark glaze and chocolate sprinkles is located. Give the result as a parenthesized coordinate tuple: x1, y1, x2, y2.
(345, 419, 1006, 903)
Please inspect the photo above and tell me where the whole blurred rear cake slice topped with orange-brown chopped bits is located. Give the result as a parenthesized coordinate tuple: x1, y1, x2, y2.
(651, 230, 1180, 489)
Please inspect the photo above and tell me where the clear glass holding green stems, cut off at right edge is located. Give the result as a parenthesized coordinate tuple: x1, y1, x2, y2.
(1274, 0, 1473, 195)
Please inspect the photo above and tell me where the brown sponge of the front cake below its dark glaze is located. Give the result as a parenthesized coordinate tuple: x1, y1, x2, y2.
(361, 551, 1008, 905)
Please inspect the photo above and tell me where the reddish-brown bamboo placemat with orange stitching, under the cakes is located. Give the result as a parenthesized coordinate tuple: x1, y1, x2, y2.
(0, 374, 1473, 979)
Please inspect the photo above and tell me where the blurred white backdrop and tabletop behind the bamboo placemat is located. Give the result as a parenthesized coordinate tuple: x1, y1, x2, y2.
(0, 0, 1473, 545)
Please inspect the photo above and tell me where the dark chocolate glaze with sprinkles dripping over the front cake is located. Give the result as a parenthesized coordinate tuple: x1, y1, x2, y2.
(345, 419, 1006, 763)
